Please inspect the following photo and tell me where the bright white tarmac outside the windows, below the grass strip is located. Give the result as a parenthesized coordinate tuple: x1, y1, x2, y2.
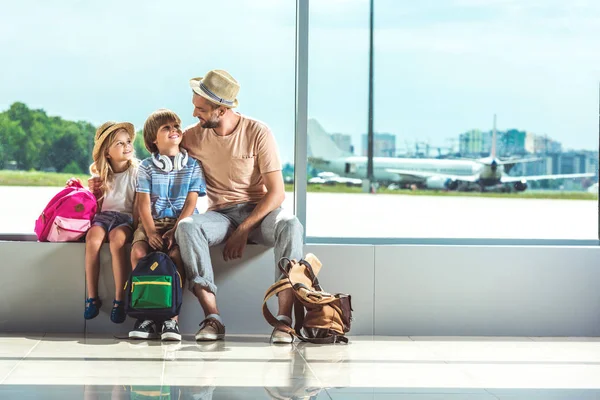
(0, 186, 598, 240)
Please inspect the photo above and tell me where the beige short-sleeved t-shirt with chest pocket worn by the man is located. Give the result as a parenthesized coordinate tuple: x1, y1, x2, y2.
(181, 114, 281, 210)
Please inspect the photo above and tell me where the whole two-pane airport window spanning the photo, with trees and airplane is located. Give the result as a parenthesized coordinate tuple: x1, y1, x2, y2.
(0, 0, 600, 239)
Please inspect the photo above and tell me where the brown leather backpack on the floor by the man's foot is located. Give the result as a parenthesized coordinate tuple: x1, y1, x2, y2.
(263, 253, 352, 344)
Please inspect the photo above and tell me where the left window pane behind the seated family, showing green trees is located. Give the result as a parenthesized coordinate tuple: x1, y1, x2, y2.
(0, 0, 296, 234)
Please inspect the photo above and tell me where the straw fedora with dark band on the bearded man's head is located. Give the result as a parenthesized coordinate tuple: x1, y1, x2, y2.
(190, 69, 240, 108)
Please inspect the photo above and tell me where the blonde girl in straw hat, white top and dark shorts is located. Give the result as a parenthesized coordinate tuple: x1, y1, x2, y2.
(84, 121, 138, 324)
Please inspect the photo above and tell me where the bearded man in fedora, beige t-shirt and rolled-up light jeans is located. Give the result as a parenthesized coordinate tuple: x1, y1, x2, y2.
(175, 70, 303, 343)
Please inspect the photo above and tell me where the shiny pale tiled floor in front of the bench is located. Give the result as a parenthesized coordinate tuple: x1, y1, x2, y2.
(0, 334, 600, 400)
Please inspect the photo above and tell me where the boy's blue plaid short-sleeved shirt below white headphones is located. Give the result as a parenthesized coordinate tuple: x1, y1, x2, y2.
(136, 157, 206, 219)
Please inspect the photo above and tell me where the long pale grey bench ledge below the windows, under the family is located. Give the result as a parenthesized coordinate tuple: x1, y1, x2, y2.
(0, 241, 600, 336)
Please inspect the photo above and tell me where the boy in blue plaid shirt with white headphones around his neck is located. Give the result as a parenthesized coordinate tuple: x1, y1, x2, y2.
(129, 109, 206, 341)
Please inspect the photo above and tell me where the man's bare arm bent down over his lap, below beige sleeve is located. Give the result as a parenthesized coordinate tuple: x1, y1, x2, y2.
(223, 171, 285, 261)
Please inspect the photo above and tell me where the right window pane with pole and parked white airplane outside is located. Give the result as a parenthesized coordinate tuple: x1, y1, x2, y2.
(307, 0, 600, 239)
